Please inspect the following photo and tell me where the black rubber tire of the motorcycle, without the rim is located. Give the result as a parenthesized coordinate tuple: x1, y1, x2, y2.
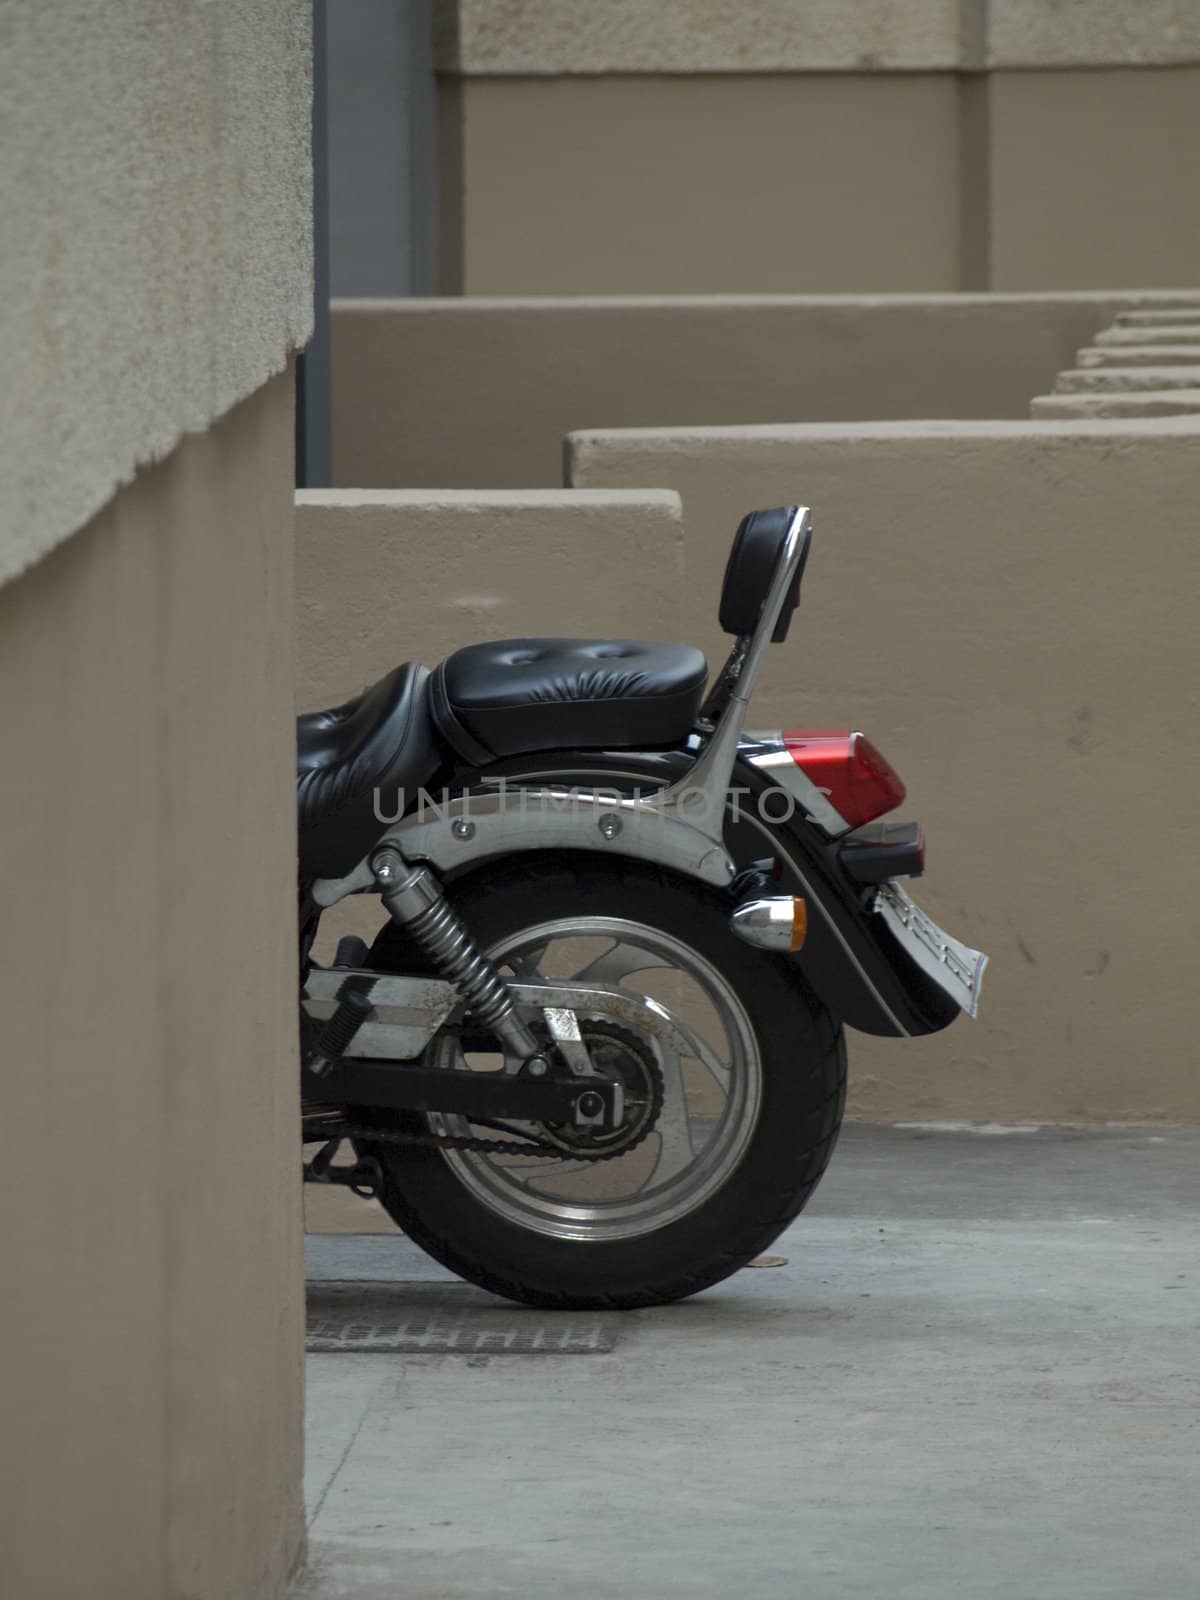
(362, 856, 846, 1309)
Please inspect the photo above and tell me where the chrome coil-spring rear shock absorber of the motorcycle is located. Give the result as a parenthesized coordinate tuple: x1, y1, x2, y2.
(371, 850, 547, 1077)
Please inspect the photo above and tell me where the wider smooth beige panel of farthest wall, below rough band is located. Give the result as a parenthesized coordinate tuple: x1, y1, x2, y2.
(442, 72, 960, 294)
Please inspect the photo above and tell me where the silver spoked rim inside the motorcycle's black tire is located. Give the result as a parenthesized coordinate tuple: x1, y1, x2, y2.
(429, 917, 762, 1243)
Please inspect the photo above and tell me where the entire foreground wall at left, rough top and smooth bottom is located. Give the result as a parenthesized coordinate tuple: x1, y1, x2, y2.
(0, 0, 312, 1600)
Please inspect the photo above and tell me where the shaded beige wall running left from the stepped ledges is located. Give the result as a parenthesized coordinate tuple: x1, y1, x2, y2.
(333, 293, 1200, 488)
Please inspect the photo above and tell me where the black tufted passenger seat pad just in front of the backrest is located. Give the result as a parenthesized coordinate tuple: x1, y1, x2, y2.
(430, 638, 709, 766)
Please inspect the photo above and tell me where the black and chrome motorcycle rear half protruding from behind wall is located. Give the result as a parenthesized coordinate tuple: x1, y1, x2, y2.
(298, 506, 986, 1309)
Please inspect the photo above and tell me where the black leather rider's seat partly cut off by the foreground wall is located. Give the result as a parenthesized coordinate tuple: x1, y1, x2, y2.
(296, 666, 442, 878)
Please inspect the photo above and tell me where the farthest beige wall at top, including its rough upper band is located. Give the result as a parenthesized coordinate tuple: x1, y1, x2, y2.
(437, 0, 1200, 294)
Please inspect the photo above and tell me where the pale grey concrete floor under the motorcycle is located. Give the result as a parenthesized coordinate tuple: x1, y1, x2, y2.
(302, 1128, 1200, 1600)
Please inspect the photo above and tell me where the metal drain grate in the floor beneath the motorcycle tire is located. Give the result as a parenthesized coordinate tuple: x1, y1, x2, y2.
(306, 1283, 618, 1355)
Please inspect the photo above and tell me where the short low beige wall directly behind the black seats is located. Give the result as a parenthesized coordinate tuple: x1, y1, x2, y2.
(296, 490, 683, 710)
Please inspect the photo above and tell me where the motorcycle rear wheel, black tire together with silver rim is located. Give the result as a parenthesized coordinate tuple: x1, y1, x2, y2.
(358, 856, 846, 1309)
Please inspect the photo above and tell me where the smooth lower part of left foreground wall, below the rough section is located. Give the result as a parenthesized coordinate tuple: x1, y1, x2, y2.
(0, 371, 302, 1600)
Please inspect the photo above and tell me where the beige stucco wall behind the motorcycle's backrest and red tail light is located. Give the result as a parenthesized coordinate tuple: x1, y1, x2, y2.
(570, 418, 1200, 1122)
